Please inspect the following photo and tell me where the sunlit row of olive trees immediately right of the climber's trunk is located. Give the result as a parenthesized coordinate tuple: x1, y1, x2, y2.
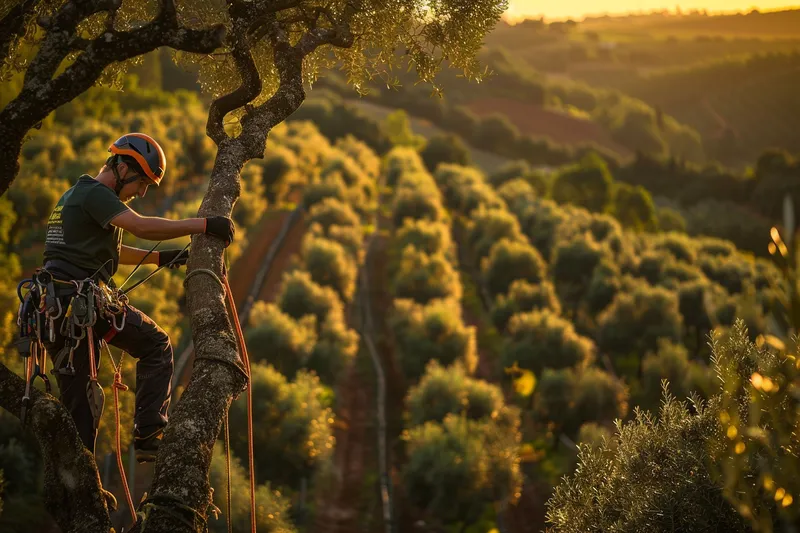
(231, 122, 388, 525)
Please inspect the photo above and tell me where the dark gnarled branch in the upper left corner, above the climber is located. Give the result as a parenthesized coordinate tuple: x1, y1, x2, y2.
(0, 0, 224, 195)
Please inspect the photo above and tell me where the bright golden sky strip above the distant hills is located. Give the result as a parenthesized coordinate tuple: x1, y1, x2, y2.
(506, 0, 797, 20)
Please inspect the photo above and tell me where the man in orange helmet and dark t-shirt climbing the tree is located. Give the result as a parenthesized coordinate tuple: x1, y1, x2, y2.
(44, 133, 234, 462)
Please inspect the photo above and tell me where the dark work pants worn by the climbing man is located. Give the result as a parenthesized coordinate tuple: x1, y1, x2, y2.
(45, 290, 173, 453)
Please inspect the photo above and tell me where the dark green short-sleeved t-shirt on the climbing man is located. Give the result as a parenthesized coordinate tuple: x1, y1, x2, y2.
(44, 174, 128, 277)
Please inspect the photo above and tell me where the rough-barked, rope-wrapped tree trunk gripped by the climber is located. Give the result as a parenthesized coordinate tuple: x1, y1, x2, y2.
(131, 139, 247, 533)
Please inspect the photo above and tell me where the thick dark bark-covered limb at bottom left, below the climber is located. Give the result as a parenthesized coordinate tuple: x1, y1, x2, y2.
(0, 364, 111, 533)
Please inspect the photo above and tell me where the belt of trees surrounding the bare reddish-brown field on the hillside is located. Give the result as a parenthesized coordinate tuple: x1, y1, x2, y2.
(321, 43, 705, 165)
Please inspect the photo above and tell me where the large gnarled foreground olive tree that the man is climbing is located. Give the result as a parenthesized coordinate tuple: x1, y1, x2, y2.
(0, 0, 506, 533)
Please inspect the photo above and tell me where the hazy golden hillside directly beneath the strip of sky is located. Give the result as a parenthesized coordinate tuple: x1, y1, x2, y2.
(486, 12, 800, 79)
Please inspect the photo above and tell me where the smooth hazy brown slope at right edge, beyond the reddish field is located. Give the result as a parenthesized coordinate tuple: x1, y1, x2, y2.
(618, 53, 800, 164)
